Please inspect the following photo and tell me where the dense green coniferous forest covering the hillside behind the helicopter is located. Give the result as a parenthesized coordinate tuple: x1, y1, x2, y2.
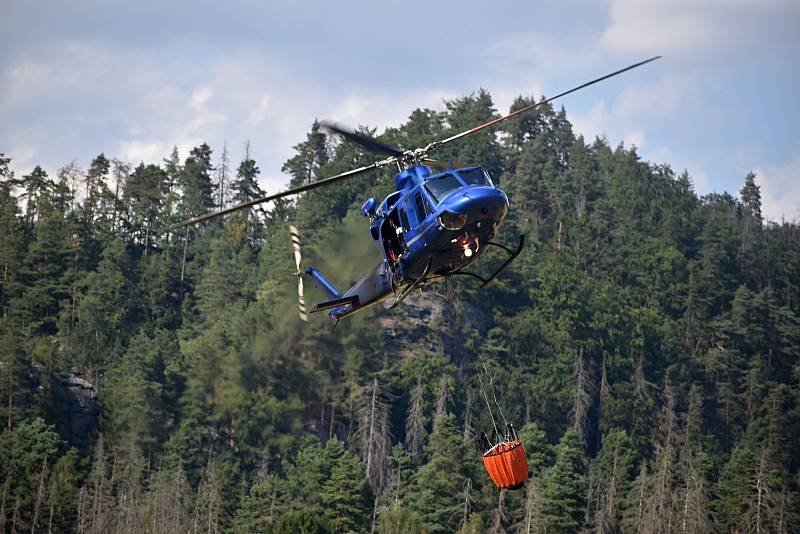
(0, 91, 800, 534)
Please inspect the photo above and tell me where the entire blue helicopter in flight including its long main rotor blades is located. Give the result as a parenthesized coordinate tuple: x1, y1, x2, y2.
(176, 56, 661, 327)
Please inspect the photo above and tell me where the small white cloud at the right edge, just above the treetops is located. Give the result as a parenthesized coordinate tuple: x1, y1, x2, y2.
(755, 149, 800, 222)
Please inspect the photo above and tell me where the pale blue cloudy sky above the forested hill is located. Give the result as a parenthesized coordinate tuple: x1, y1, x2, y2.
(0, 0, 800, 220)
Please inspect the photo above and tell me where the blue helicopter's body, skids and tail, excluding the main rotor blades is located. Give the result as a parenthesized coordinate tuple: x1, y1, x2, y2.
(290, 159, 524, 321)
